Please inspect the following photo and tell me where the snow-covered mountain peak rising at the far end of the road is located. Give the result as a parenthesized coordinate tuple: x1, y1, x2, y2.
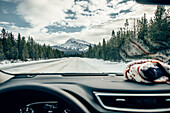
(53, 38, 93, 54)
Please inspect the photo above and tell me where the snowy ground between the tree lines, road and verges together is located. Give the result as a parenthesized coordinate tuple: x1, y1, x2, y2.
(0, 57, 126, 73)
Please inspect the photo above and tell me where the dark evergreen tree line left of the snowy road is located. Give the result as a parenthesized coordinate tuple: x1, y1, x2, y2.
(0, 28, 64, 61)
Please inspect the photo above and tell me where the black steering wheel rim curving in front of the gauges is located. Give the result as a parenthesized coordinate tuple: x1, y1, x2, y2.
(0, 83, 90, 113)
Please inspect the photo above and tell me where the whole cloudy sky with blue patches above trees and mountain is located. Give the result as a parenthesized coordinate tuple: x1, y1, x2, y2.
(0, 0, 160, 45)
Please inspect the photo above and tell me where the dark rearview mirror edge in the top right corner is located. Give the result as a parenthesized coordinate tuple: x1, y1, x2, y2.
(136, 0, 170, 5)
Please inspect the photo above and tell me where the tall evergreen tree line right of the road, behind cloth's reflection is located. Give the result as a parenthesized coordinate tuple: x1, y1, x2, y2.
(83, 5, 170, 61)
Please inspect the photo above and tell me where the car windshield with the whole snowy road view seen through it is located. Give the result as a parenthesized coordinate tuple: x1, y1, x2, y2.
(0, 0, 170, 73)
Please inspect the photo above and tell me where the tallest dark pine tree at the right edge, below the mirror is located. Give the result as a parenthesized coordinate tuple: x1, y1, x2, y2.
(149, 5, 170, 47)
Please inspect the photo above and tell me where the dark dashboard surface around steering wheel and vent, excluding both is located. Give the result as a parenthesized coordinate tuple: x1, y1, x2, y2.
(0, 75, 170, 112)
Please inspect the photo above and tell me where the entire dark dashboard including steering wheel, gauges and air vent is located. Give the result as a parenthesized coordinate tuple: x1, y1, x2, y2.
(0, 75, 170, 113)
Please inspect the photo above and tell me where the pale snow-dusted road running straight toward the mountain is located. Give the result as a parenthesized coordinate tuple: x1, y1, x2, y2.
(2, 57, 101, 73)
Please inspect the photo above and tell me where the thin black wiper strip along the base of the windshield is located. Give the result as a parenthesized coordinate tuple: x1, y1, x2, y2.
(0, 70, 123, 77)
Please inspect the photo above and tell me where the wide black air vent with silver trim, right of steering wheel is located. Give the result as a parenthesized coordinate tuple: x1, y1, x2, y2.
(94, 92, 170, 112)
